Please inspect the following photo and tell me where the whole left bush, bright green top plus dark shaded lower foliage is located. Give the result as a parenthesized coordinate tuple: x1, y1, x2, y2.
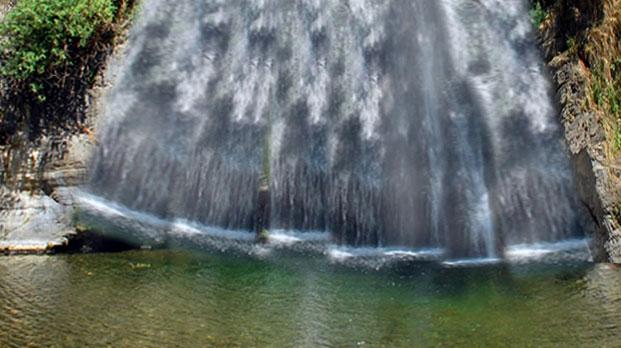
(0, 0, 133, 144)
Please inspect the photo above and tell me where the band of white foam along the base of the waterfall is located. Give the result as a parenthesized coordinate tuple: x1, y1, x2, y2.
(72, 191, 591, 269)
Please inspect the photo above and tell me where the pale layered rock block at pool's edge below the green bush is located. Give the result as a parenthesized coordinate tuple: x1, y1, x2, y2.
(0, 119, 95, 252)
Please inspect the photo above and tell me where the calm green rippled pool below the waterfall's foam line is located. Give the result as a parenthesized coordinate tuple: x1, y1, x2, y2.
(0, 251, 621, 347)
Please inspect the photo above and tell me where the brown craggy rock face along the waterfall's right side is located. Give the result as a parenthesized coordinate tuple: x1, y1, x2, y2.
(540, 0, 621, 263)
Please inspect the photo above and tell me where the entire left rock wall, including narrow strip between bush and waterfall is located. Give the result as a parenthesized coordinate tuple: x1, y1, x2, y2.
(0, 0, 135, 252)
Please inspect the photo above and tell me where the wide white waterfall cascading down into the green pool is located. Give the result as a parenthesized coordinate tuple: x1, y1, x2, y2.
(89, 0, 583, 258)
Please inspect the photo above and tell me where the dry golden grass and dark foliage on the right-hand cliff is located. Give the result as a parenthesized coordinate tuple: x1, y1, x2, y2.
(532, 0, 621, 238)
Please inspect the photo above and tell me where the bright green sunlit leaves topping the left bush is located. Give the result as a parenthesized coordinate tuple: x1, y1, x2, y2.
(0, 0, 116, 84)
